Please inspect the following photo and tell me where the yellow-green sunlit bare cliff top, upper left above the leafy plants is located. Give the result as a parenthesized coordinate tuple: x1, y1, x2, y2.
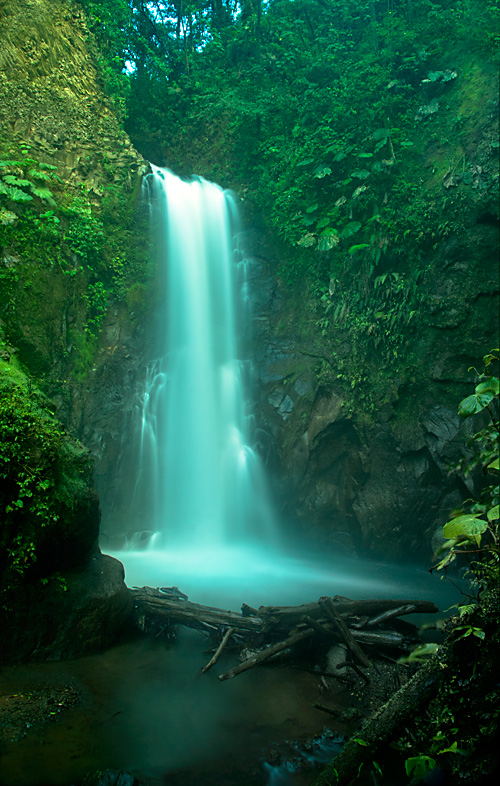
(0, 0, 144, 189)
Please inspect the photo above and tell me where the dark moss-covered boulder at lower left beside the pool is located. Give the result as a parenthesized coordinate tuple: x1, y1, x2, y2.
(0, 345, 132, 661)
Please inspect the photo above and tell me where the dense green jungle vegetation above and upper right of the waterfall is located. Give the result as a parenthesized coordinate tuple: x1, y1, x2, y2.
(82, 0, 500, 404)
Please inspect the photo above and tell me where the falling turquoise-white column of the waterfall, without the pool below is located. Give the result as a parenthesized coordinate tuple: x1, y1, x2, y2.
(135, 166, 275, 549)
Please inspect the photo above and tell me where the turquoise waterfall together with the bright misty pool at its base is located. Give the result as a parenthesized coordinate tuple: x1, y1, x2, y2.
(110, 167, 454, 608)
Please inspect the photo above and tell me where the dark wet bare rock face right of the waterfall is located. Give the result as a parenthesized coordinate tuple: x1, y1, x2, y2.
(246, 224, 496, 561)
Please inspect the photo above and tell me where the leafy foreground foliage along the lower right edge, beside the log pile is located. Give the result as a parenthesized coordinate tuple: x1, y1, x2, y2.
(395, 350, 500, 783)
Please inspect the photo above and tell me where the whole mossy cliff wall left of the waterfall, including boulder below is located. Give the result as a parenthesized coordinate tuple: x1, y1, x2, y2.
(0, 0, 146, 660)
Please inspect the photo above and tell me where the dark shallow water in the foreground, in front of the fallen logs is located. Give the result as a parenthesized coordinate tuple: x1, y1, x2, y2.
(0, 630, 356, 786)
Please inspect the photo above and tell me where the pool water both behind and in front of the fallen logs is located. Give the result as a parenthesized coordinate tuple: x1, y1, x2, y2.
(0, 552, 459, 786)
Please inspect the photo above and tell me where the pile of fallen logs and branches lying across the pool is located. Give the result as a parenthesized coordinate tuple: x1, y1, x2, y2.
(132, 587, 438, 680)
